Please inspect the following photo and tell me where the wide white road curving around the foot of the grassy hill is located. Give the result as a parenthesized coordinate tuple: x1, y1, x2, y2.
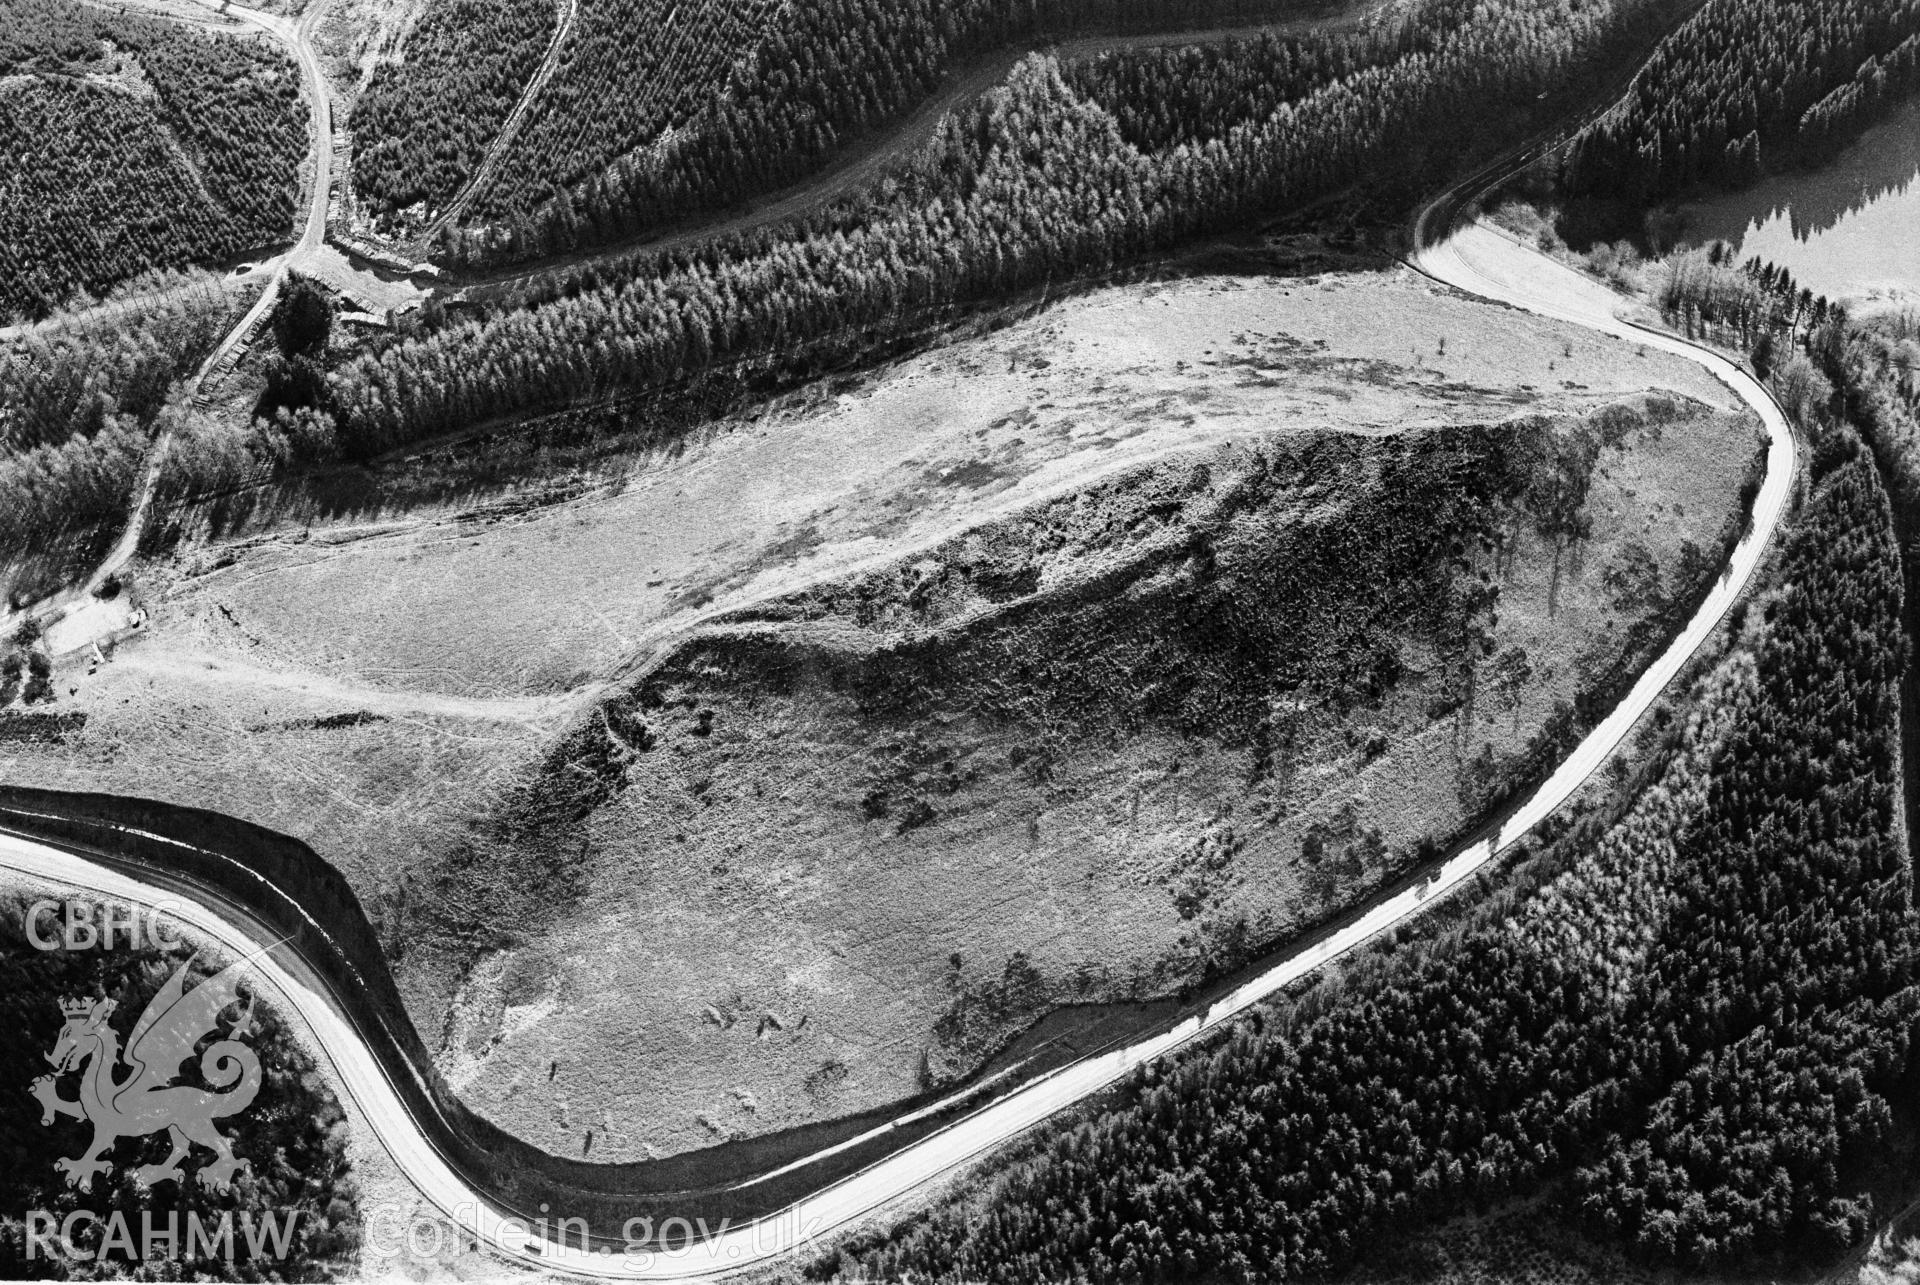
(0, 225, 1795, 1279)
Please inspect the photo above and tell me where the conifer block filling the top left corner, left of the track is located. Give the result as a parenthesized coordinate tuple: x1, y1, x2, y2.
(0, 0, 307, 317)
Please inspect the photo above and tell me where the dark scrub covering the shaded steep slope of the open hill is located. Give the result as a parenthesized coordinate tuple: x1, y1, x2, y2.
(397, 405, 1745, 1037)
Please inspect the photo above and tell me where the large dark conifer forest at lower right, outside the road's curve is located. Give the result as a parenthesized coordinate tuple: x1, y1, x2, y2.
(822, 428, 1916, 1279)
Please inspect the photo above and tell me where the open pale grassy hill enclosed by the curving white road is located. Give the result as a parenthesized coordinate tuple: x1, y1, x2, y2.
(0, 275, 1753, 1158)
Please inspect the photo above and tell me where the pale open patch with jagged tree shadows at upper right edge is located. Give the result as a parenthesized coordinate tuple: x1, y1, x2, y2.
(1686, 100, 1920, 311)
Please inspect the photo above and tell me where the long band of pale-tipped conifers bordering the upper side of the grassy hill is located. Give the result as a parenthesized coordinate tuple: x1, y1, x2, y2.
(318, 0, 1712, 449)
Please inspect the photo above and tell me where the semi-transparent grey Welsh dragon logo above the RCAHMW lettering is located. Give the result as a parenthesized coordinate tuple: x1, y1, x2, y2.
(33, 960, 261, 1191)
